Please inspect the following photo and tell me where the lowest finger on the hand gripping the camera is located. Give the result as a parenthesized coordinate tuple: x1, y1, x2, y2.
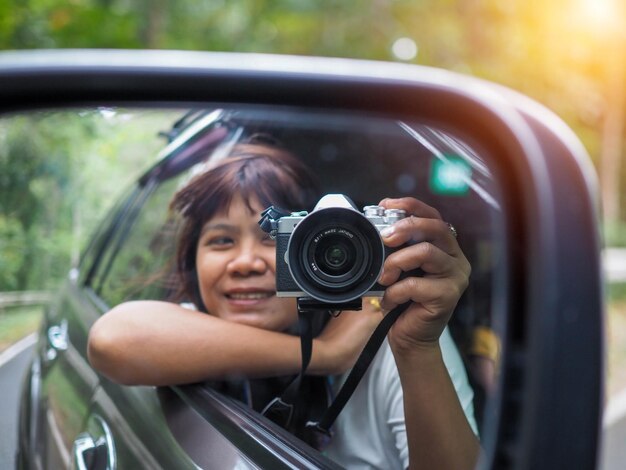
(380, 277, 467, 316)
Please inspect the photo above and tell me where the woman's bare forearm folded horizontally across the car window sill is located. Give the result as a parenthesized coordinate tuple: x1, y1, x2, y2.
(88, 301, 338, 385)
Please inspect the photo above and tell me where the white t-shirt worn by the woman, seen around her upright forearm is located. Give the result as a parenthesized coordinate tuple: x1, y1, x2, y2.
(324, 328, 478, 470)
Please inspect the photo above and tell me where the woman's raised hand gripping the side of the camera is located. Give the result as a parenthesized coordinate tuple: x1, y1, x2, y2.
(379, 198, 471, 350)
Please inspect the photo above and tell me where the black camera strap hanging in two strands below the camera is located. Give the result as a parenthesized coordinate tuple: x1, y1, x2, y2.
(262, 302, 411, 436)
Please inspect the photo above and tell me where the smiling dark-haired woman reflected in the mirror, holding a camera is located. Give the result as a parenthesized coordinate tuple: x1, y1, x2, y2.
(89, 138, 478, 469)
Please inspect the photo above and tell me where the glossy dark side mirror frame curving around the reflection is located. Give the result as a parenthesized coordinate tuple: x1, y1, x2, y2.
(0, 50, 603, 470)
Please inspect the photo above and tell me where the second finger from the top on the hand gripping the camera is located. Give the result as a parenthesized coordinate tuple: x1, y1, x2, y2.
(380, 216, 461, 256)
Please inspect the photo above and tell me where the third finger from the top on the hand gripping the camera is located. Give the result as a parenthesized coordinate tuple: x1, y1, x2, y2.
(378, 242, 458, 286)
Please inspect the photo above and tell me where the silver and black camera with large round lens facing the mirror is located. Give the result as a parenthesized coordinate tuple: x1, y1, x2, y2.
(261, 194, 405, 310)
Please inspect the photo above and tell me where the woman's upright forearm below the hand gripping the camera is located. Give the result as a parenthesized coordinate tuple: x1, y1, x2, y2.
(394, 345, 480, 470)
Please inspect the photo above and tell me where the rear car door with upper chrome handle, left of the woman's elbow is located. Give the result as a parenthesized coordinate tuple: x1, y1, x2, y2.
(37, 183, 145, 468)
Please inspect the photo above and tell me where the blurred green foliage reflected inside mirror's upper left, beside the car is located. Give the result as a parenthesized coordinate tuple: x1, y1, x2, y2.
(0, 109, 181, 291)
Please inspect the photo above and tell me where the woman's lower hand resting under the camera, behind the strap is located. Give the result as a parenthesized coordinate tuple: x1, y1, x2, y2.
(310, 298, 383, 375)
